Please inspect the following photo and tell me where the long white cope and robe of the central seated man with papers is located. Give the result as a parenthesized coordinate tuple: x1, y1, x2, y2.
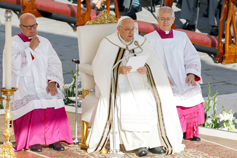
(87, 32, 184, 154)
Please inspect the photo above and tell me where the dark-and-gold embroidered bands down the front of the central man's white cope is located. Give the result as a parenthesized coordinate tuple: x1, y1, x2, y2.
(94, 48, 173, 155)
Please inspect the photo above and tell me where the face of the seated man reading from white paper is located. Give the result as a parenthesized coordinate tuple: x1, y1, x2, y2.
(117, 19, 134, 42)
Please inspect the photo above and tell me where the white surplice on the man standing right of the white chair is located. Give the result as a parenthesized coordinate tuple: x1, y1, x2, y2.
(145, 30, 204, 107)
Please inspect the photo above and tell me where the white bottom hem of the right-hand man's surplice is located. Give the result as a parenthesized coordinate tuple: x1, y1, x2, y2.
(174, 93, 204, 107)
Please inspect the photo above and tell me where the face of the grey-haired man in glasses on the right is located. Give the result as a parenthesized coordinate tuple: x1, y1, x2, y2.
(157, 10, 175, 31)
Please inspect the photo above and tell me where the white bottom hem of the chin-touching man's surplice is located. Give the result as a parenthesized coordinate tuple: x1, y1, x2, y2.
(11, 99, 65, 120)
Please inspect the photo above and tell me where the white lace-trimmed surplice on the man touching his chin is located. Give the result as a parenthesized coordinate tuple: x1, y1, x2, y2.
(3, 35, 64, 120)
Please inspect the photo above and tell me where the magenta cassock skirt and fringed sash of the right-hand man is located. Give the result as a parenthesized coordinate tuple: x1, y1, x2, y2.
(177, 103, 205, 139)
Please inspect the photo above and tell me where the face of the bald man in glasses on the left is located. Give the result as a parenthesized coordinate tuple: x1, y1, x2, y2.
(19, 15, 38, 37)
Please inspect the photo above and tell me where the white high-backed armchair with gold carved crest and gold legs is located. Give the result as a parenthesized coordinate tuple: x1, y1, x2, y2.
(77, 10, 138, 149)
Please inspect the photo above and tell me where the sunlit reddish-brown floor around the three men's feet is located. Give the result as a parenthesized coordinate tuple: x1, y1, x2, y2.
(0, 112, 237, 158)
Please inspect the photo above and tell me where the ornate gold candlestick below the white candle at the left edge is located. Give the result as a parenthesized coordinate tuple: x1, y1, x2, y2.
(0, 87, 17, 158)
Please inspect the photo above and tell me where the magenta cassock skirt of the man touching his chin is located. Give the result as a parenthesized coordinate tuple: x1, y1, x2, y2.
(13, 107, 73, 151)
